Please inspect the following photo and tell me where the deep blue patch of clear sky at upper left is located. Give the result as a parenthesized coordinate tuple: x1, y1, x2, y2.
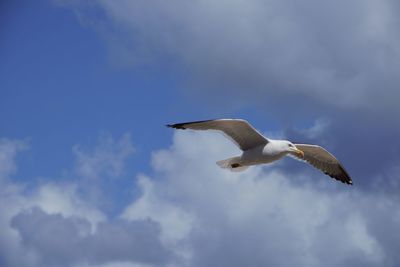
(1, 1, 175, 176)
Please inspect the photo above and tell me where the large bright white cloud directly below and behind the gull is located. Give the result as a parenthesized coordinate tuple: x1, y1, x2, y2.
(124, 132, 400, 266)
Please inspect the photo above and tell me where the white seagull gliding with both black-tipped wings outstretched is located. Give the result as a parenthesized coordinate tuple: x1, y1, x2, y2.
(167, 119, 353, 185)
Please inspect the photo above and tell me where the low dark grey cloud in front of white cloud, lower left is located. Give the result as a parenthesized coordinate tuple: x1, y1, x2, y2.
(11, 208, 169, 266)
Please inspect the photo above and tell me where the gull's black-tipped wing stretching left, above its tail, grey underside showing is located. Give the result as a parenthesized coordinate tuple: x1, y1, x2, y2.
(167, 119, 268, 151)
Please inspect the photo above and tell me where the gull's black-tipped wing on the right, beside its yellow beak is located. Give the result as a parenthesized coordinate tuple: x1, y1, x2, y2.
(295, 144, 353, 185)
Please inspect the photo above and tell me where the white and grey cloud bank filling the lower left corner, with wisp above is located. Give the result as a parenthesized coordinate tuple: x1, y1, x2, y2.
(0, 135, 173, 267)
